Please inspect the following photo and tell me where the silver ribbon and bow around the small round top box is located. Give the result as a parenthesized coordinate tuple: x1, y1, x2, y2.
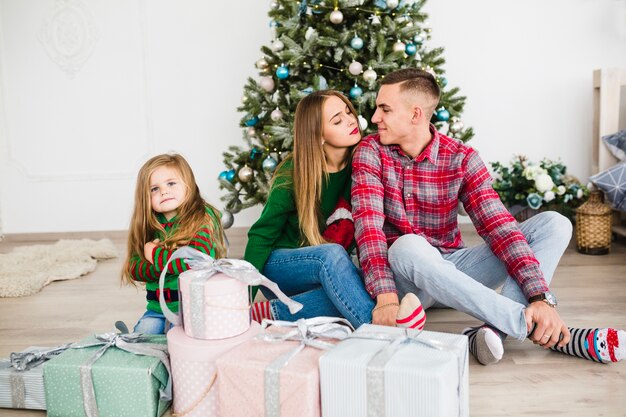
(159, 246, 302, 335)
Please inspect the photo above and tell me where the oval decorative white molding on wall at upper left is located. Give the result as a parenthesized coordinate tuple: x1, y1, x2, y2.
(39, 0, 98, 78)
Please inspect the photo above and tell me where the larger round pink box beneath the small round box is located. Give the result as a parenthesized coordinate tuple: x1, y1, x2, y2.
(167, 322, 261, 417)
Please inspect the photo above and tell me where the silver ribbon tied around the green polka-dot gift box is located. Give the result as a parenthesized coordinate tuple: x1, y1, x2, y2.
(70, 333, 172, 417)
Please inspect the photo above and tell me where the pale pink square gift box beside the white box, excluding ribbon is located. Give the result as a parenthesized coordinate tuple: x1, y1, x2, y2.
(216, 339, 325, 417)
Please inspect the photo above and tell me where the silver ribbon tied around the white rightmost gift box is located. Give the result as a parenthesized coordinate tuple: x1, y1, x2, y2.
(350, 329, 467, 417)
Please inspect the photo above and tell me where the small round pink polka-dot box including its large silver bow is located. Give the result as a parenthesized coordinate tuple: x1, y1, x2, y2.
(159, 247, 302, 340)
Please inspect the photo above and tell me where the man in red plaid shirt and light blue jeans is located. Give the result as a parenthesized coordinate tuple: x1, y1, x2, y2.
(352, 68, 572, 365)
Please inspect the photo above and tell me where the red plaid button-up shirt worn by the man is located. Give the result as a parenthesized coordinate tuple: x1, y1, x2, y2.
(352, 125, 548, 298)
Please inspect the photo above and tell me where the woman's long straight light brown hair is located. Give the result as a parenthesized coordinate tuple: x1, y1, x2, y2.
(292, 90, 360, 245)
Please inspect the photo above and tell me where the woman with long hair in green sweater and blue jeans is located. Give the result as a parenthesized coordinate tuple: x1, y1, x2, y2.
(244, 90, 423, 328)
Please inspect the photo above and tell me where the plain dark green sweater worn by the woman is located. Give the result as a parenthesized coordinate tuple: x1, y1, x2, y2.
(244, 161, 352, 272)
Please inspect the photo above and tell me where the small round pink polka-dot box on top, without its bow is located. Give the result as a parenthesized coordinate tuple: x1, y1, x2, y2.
(178, 269, 250, 340)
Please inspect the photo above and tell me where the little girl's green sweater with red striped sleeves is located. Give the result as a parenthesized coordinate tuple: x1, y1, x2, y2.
(131, 207, 219, 313)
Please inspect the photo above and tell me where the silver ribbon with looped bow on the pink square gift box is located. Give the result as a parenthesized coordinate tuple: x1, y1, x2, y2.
(256, 317, 353, 417)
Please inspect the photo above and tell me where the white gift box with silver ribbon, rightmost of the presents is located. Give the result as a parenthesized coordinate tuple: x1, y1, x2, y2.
(320, 325, 469, 417)
